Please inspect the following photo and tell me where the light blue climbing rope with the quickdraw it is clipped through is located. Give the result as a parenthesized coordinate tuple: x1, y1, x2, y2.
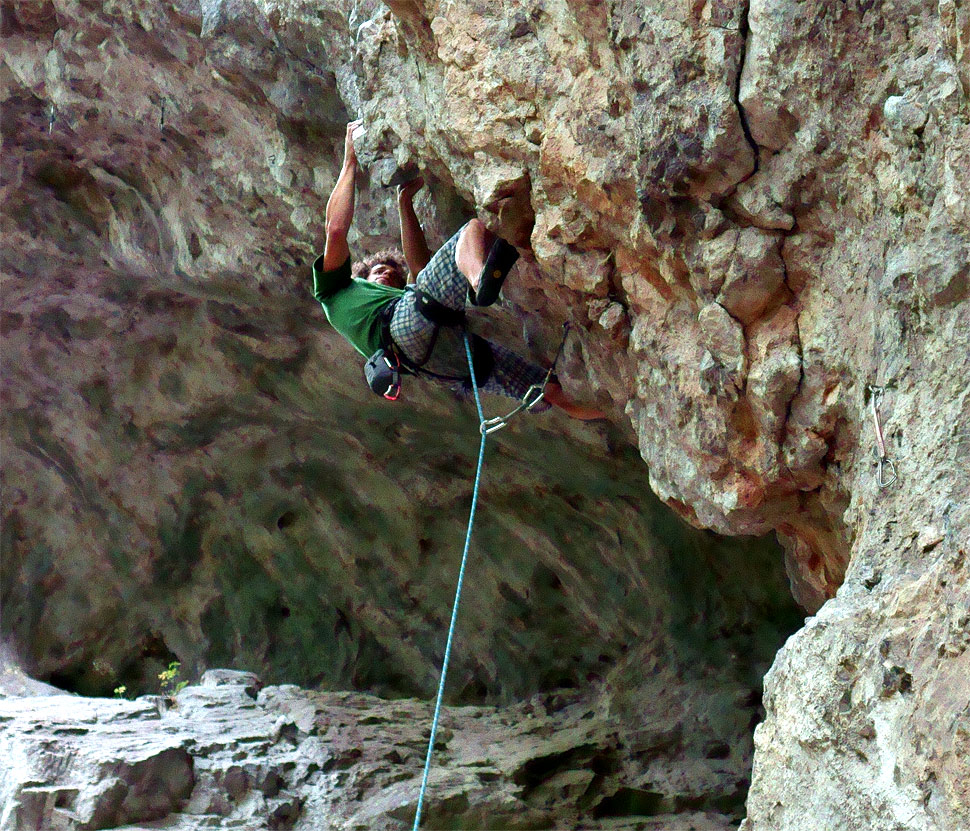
(412, 328, 569, 831)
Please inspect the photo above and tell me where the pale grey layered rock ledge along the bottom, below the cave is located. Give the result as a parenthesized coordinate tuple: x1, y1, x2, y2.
(0, 670, 735, 831)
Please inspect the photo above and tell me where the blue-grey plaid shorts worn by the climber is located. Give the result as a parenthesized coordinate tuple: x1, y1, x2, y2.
(391, 223, 549, 412)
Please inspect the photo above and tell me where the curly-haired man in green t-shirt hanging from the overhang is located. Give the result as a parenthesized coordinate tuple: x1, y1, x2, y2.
(313, 121, 603, 421)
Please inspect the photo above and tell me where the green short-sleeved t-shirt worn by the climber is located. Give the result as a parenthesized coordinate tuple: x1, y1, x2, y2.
(313, 254, 404, 358)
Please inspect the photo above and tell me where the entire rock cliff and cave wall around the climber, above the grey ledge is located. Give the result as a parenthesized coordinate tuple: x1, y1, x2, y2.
(0, 0, 970, 831)
